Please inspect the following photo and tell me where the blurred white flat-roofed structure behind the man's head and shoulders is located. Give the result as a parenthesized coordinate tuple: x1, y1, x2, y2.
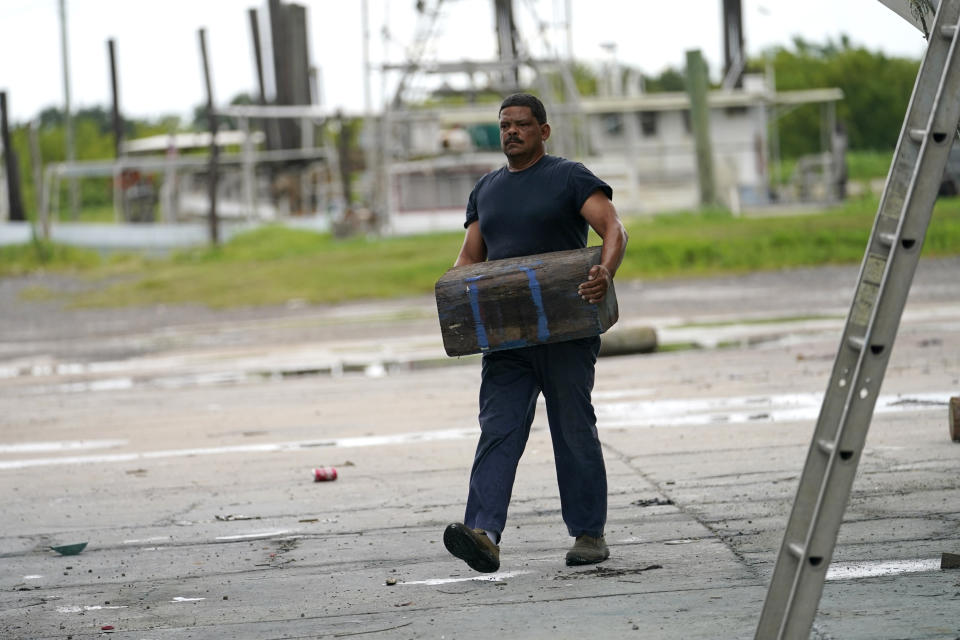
(387, 77, 843, 233)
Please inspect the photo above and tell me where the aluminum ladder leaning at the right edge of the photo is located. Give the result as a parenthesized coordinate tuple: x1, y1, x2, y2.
(755, 0, 960, 640)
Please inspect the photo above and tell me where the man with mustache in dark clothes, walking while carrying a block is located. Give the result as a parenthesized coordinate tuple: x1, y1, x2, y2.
(443, 94, 627, 572)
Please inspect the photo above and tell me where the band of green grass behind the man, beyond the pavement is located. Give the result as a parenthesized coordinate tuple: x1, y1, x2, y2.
(0, 198, 960, 307)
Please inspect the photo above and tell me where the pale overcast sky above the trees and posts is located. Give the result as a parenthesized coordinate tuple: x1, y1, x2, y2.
(0, 0, 925, 122)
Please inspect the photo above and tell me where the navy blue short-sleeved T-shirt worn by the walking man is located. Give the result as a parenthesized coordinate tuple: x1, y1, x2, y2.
(464, 156, 613, 260)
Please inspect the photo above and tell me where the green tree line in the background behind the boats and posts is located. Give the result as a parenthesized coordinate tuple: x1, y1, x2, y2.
(3, 37, 919, 216)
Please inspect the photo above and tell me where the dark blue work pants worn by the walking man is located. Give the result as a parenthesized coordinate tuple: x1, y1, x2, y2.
(464, 337, 607, 537)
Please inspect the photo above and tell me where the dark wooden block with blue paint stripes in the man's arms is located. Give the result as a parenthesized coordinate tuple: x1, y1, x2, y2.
(435, 247, 618, 356)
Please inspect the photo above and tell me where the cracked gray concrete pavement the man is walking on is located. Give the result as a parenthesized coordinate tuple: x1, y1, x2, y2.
(0, 260, 960, 639)
